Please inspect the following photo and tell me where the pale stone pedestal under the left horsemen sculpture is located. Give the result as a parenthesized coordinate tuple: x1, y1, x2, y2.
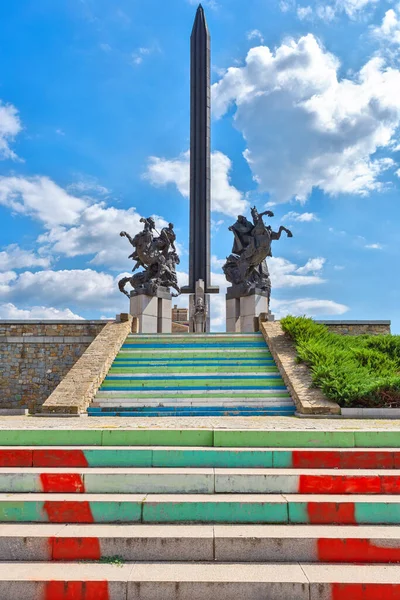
(130, 287, 172, 333)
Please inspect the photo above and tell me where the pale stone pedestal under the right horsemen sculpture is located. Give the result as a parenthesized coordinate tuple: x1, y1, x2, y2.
(226, 288, 274, 333)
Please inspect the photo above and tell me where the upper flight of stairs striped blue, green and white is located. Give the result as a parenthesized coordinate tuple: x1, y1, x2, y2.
(88, 334, 295, 417)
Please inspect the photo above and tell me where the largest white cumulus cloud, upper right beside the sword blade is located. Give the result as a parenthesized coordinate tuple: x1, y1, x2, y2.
(213, 34, 400, 202)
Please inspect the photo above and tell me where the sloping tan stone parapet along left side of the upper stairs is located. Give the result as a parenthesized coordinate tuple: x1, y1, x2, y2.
(40, 317, 132, 414)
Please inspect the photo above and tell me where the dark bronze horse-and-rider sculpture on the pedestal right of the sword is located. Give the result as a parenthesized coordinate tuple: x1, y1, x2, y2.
(222, 206, 292, 302)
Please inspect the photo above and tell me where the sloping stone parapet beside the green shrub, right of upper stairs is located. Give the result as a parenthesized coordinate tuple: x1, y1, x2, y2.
(260, 319, 340, 415)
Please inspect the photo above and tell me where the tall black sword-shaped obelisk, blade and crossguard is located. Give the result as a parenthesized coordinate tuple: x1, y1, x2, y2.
(182, 4, 219, 318)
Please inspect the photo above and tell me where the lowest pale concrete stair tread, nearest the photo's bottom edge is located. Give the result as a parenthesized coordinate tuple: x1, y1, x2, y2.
(0, 562, 400, 580)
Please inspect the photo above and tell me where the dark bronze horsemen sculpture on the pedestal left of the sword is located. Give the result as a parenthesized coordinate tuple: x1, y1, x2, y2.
(118, 217, 181, 298)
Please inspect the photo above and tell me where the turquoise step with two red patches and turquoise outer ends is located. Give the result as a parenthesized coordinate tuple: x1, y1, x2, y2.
(0, 493, 400, 525)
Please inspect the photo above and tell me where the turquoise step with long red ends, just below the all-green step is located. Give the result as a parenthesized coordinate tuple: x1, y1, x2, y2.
(0, 446, 400, 470)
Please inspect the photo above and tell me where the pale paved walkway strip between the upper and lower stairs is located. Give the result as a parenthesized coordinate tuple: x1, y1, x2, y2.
(0, 416, 400, 428)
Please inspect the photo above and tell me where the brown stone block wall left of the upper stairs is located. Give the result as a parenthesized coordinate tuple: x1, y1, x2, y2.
(0, 320, 108, 409)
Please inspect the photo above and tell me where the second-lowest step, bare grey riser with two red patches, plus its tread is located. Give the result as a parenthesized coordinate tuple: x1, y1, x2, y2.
(0, 523, 400, 564)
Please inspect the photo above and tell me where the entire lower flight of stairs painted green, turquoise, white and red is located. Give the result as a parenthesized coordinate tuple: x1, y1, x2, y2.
(0, 428, 400, 600)
